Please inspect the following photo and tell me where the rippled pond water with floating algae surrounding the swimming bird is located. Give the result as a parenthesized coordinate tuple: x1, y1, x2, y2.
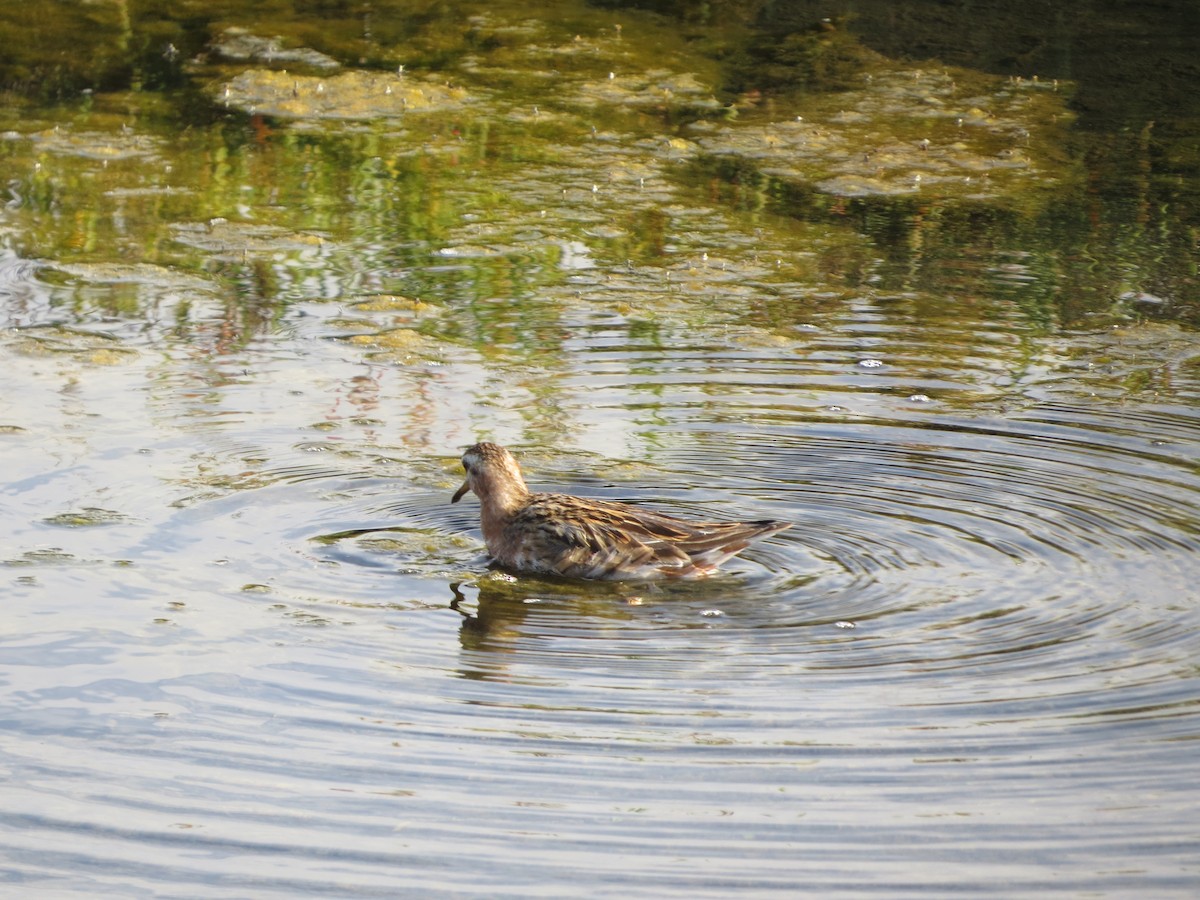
(0, 0, 1200, 896)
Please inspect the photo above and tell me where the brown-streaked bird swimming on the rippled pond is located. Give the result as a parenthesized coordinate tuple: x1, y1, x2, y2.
(450, 442, 791, 581)
